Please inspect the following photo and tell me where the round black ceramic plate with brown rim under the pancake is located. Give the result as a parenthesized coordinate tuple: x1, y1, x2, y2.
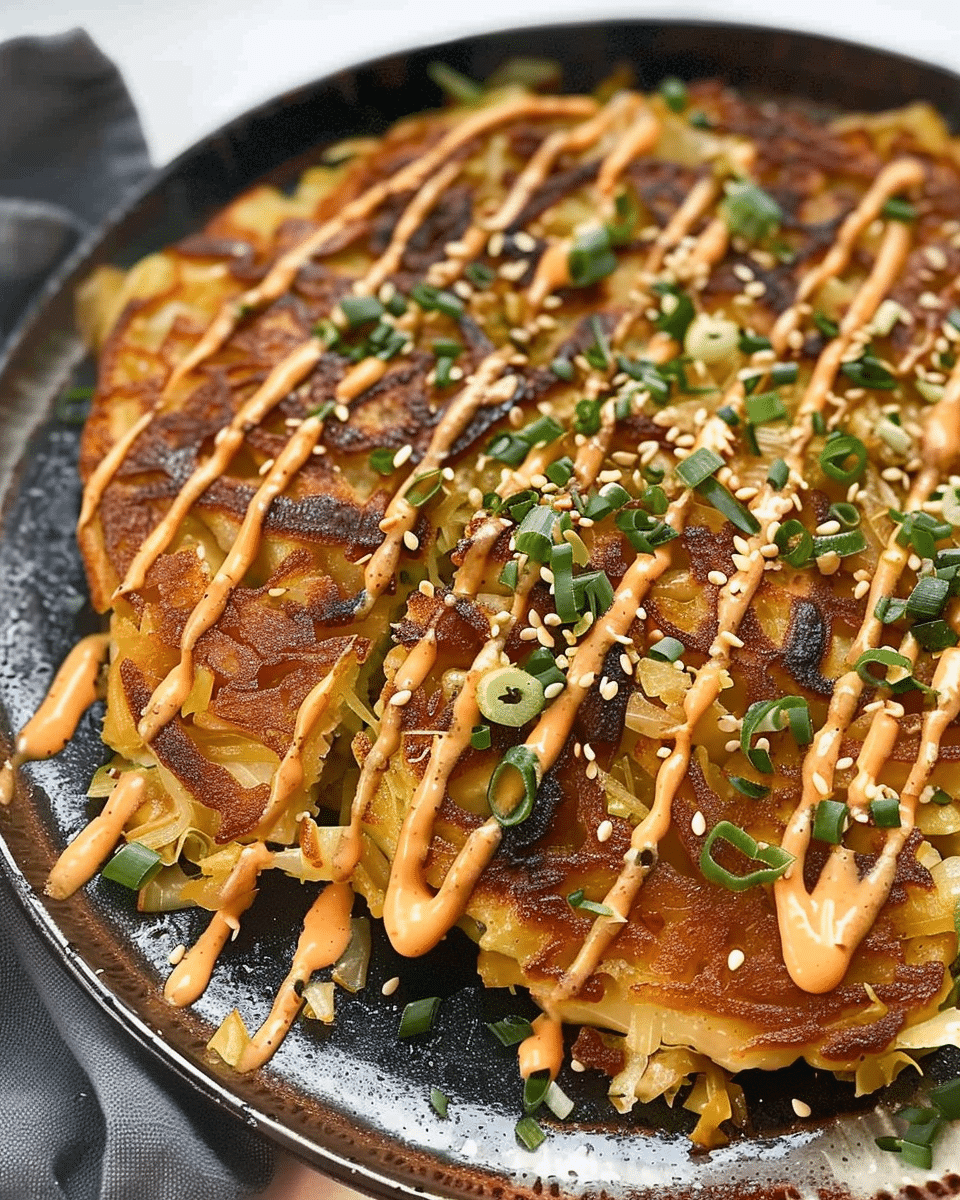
(0, 22, 960, 1200)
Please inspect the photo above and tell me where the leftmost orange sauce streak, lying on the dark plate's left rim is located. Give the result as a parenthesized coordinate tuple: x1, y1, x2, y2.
(0, 634, 110, 804)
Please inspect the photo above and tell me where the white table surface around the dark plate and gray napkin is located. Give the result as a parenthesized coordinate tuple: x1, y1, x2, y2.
(0, 0, 960, 1200)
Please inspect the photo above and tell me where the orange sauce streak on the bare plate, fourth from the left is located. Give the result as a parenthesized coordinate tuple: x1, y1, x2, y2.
(236, 883, 353, 1072)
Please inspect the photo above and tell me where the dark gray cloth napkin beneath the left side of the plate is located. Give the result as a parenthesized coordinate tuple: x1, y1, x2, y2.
(0, 31, 272, 1200)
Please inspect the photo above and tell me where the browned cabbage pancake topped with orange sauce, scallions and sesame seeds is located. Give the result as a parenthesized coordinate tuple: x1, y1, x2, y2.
(19, 70, 960, 1145)
